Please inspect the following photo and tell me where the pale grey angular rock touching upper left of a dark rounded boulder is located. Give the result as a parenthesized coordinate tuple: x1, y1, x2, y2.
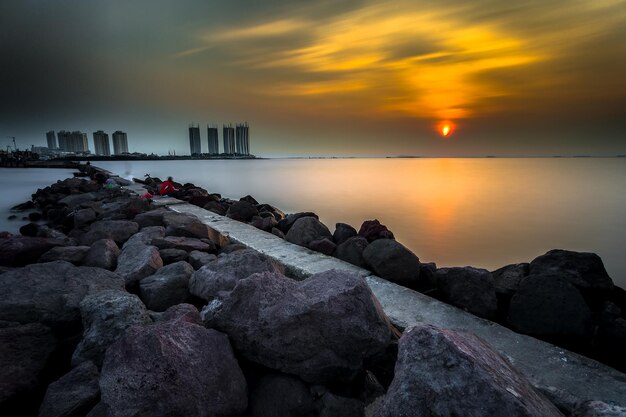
(115, 244, 163, 285)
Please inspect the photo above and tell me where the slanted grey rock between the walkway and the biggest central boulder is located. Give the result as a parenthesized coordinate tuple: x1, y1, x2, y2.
(189, 249, 285, 301)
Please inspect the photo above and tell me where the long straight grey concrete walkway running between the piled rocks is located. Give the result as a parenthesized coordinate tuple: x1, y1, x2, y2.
(139, 193, 626, 406)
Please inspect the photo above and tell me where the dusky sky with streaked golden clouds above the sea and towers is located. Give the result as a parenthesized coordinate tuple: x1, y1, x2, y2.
(0, 0, 626, 157)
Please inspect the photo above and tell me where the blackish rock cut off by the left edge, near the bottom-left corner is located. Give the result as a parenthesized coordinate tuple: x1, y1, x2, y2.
(0, 322, 58, 415)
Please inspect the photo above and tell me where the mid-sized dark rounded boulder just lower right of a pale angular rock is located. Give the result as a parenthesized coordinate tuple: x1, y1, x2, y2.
(139, 261, 194, 311)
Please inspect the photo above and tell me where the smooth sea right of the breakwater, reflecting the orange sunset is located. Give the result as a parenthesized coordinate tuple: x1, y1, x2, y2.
(1, 158, 626, 287)
